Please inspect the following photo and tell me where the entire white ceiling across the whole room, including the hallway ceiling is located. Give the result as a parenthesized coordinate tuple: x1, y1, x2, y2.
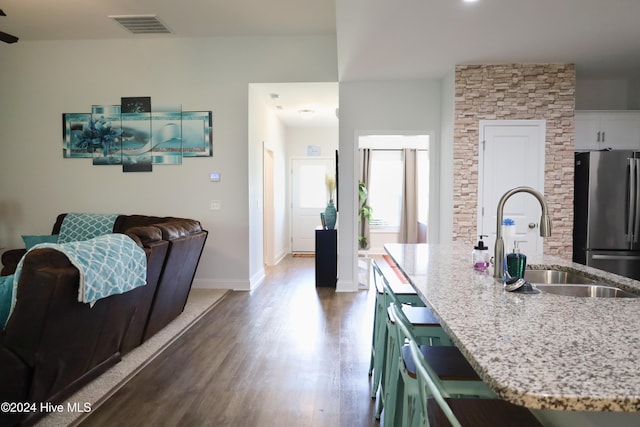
(0, 0, 640, 123)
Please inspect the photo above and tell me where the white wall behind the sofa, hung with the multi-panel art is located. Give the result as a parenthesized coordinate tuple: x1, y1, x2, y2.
(0, 37, 337, 289)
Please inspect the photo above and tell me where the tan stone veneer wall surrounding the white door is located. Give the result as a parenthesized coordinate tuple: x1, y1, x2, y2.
(453, 64, 575, 259)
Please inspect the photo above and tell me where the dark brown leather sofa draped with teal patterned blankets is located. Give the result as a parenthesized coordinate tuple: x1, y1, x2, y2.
(0, 214, 207, 426)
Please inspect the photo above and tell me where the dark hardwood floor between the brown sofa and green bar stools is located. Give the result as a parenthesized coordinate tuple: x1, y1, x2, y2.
(81, 256, 378, 427)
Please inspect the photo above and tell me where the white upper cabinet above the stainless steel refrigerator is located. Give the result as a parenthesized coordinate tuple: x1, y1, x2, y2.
(574, 111, 640, 151)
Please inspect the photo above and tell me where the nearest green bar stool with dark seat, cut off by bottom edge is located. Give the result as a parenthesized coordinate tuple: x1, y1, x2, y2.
(408, 340, 542, 427)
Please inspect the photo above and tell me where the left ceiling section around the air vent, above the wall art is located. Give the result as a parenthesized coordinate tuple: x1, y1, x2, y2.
(0, 0, 335, 40)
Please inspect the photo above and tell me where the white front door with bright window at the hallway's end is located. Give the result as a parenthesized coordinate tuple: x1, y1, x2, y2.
(291, 157, 335, 252)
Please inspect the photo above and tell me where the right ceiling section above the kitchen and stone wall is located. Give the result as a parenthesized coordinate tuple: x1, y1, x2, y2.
(337, 0, 640, 81)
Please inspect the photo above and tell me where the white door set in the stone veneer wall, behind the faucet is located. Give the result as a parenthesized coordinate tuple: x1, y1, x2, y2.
(478, 120, 546, 255)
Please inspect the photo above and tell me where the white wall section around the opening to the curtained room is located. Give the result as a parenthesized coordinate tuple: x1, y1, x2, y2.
(337, 80, 441, 291)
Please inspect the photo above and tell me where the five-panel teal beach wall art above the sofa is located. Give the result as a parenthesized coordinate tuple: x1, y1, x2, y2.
(62, 97, 213, 172)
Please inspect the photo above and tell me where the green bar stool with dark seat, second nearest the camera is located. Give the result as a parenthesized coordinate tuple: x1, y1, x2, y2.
(383, 303, 497, 427)
